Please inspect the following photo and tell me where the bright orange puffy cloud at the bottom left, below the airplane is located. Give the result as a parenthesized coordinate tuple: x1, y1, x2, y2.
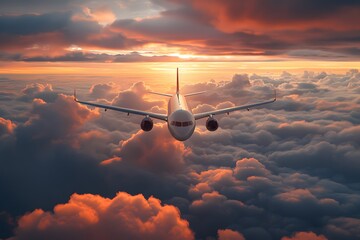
(13, 192, 194, 239)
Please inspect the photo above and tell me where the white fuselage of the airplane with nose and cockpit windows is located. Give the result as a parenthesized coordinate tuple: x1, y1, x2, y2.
(167, 93, 196, 141)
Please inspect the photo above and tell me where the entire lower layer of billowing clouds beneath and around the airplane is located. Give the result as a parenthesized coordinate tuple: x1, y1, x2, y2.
(0, 70, 360, 240)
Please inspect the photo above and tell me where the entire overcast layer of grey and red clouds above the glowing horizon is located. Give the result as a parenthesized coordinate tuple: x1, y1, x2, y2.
(0, 0, 359, 62)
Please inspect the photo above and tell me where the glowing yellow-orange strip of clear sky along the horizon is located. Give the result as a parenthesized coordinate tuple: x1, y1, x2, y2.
(0, 61, 360, 93)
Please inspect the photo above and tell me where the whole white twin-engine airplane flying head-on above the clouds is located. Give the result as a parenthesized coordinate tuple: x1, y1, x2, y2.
(74, 68, 276, 141)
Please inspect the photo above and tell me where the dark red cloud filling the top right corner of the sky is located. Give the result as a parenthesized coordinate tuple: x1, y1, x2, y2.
(192, 0, 359, 31)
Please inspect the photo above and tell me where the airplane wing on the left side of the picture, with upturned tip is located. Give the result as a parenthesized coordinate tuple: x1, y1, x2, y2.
(74, 92, 167, 121)
